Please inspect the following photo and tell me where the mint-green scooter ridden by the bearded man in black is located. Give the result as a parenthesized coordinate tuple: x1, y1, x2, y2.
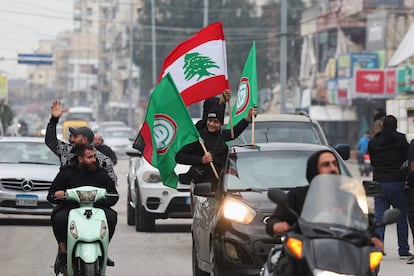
(54, 186, 119, 276)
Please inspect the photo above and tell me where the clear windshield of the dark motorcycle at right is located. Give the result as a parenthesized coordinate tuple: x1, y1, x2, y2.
(301, 175, 368, 230)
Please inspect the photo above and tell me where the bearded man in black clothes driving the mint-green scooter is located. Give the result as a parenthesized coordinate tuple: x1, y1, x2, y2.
(47, 144, 118, 272)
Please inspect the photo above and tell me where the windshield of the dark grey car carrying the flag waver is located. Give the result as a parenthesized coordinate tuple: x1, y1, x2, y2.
(224, 149, 347, 190)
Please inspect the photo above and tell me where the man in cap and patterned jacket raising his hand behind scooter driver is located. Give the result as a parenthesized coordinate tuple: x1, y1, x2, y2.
(45, 101, 117, 183)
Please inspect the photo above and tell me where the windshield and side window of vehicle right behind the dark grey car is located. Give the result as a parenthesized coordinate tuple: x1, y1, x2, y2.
(229, 121, 325, 145)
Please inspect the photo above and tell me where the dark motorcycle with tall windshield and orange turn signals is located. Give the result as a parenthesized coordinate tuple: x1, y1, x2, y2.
(260, 175, 400, 276)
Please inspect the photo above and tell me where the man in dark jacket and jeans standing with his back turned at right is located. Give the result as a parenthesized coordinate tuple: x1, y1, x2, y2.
(368, 115, 411, 259)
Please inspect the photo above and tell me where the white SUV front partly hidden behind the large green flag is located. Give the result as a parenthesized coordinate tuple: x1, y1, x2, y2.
(126, 147, 192, 232)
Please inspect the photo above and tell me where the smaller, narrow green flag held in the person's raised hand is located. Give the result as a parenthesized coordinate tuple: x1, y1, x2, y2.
(229, 42, 258, 127)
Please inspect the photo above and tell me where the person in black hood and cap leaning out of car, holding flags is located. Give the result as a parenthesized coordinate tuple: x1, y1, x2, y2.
(175, 105, 257, 184)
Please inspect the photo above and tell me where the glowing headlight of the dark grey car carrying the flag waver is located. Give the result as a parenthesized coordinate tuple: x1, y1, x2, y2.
(223, 197, 256, 224)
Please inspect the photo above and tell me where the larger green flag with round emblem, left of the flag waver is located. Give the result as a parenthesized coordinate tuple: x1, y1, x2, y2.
(134, 74, 200, 188)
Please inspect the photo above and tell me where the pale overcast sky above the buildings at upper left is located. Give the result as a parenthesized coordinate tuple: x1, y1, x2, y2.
(0, 0, 73, 79)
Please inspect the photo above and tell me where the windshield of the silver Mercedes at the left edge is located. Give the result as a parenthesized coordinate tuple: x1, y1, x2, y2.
(0, 141, 60, 165)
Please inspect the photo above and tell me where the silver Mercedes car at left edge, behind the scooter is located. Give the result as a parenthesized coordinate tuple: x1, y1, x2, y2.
(0, 137, 60, 215)
